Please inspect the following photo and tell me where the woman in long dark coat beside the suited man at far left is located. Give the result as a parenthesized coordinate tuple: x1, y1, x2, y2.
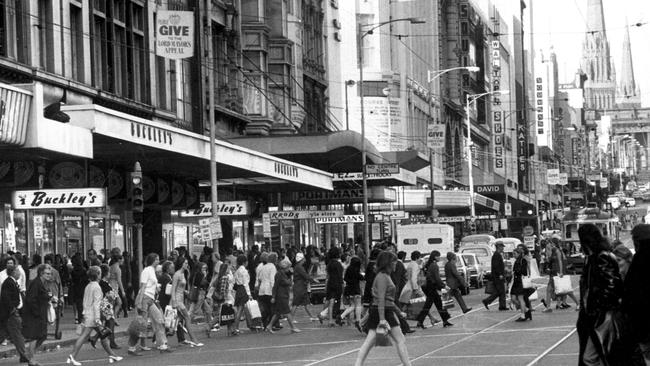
(22, 264, 56, 362)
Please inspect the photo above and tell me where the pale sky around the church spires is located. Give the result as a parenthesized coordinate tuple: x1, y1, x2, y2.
(531, 0, 650, 107)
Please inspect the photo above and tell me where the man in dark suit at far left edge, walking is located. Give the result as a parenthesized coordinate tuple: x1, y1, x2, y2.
(0, 265, 39, 366)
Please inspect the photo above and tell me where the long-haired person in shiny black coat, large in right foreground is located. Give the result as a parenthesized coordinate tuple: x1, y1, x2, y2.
(577, 224, 622, 366)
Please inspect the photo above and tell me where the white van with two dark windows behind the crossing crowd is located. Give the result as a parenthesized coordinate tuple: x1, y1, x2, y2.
(397, 224, 454, 260)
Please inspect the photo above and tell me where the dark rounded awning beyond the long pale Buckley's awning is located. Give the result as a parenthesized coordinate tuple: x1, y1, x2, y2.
(230, 131, 384, 172)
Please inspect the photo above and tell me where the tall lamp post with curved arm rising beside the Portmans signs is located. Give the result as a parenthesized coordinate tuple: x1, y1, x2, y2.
(356, 18, 426, 255)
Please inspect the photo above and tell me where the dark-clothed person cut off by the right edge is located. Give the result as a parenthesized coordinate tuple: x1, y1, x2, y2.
(621, 224, 650, 364)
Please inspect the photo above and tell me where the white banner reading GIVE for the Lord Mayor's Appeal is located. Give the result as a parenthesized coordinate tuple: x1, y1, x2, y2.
(156, 10, 194, 60)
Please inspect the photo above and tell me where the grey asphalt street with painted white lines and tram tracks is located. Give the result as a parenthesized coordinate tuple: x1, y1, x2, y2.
(0, 276, 578, 366)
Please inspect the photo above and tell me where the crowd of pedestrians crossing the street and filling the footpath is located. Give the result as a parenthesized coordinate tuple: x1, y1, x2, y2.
(0, 224, 650, 365)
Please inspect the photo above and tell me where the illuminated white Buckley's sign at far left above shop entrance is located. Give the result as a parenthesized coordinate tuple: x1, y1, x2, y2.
(11, 188, 106, 210)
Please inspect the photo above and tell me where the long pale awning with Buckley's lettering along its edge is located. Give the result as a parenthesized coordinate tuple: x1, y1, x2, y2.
(61, 104, 333, 191)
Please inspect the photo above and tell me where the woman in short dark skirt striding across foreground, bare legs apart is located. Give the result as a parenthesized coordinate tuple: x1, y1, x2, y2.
(355, 251, 411, 366)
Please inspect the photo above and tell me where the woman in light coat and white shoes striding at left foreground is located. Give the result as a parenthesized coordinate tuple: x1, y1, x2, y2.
(67, 266, 122, 366)
